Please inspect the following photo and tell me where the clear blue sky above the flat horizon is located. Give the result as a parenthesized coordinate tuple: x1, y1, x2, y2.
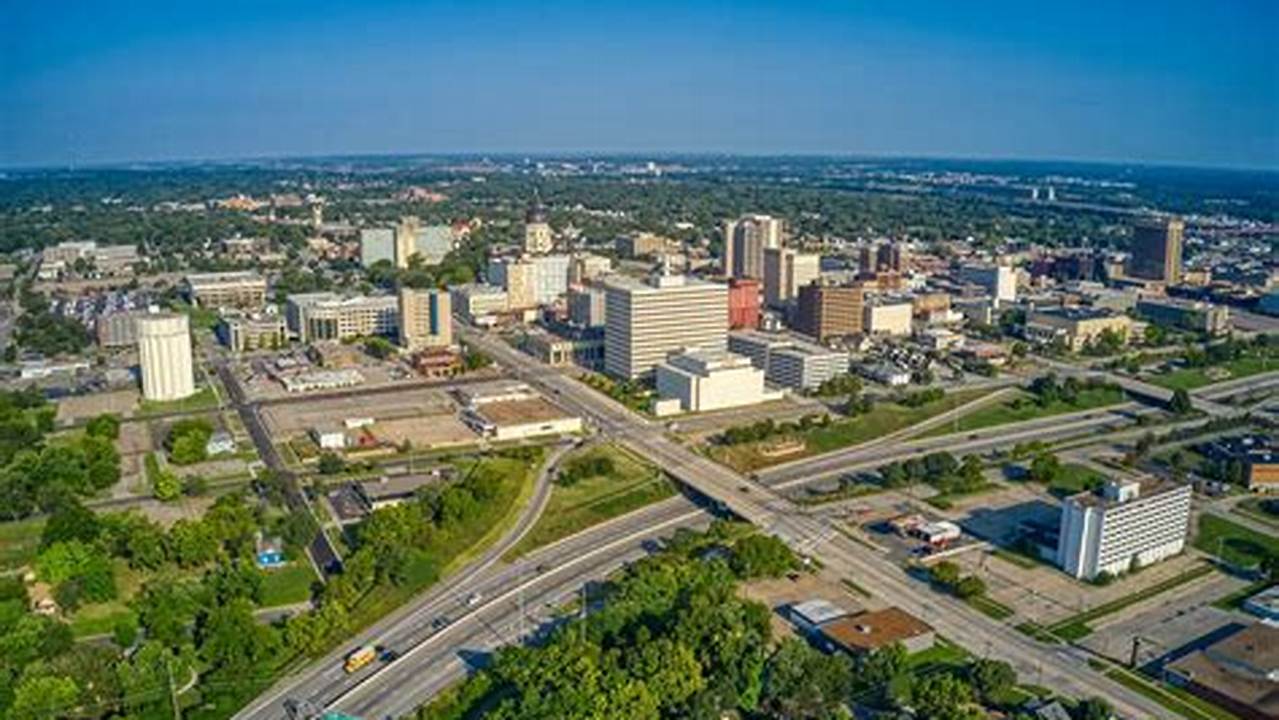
(0, 0, 1279, 169)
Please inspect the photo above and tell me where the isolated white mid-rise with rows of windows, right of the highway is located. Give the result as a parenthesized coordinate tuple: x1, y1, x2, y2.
(1056, 481, 1191, 579)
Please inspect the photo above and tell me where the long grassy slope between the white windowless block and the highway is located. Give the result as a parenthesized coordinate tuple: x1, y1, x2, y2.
(709, 389, 990, 472)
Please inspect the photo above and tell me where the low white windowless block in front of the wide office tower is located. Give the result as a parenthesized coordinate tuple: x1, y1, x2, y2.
(657, 350, 781, 413)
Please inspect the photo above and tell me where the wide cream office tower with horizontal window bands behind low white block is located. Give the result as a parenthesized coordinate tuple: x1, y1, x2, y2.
(604, 275, 728, 379)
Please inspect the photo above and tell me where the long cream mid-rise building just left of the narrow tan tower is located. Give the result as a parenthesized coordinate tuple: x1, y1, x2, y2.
(285, 293, 399, 343)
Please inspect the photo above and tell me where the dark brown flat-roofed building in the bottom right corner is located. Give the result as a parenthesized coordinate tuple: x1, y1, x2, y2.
(1164, 623, 1279, 720)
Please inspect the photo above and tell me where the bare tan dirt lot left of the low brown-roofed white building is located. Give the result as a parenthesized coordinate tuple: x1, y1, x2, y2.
(262, 387, 457, 437)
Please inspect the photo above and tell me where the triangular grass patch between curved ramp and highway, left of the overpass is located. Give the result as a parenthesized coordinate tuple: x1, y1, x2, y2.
(506, 445, 675, 559)
